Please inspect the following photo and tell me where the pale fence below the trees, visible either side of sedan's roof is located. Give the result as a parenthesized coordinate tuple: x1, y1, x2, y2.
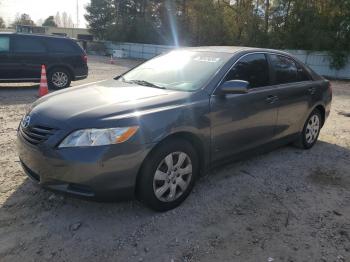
(106, 42, 350, 80)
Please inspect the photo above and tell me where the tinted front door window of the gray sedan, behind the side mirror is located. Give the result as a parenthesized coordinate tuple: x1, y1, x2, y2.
(225, 54, 270, 88)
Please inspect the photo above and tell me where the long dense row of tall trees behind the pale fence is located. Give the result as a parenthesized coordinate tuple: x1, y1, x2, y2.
(86, 0, 350, 68)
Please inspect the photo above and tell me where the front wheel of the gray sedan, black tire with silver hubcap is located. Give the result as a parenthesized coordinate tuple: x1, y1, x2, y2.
(136, 139, 199, 211)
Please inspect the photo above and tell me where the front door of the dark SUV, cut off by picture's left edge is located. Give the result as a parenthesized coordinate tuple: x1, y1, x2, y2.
(0, 34, 19, 81)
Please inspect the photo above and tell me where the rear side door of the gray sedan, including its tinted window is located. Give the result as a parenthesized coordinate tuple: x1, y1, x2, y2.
(269, 54, 316, 138)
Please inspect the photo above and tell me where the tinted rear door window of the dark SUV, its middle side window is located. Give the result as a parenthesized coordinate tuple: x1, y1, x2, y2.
(13, 37, 46, 53)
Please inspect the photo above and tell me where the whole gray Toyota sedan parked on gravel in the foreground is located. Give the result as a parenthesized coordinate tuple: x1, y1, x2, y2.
(18, 47, 332, 211)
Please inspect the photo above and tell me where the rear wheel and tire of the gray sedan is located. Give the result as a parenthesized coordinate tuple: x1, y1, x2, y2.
(294, 109, 322, 149)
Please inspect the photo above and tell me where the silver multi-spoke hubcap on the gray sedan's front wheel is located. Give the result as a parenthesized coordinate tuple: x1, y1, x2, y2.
(153, 152, 192, 202)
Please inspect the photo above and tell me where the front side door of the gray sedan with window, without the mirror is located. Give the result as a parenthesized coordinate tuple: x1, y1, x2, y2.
(210, 53, 278, 161)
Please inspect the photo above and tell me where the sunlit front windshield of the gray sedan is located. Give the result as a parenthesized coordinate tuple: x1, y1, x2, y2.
(120, 50, 230, 91)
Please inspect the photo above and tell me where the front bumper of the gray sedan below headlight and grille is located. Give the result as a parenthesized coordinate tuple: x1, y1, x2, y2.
(17, 131, 152, 200)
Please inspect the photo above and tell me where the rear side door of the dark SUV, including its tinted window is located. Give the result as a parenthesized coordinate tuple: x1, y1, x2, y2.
(12, 35, 47, 81)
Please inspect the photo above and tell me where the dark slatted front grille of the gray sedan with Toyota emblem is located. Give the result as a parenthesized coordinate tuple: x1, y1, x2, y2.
(19, 126, 56, 145)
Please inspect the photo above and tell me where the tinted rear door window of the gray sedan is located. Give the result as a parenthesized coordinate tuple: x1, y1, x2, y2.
(270, 55, 300, 84)
